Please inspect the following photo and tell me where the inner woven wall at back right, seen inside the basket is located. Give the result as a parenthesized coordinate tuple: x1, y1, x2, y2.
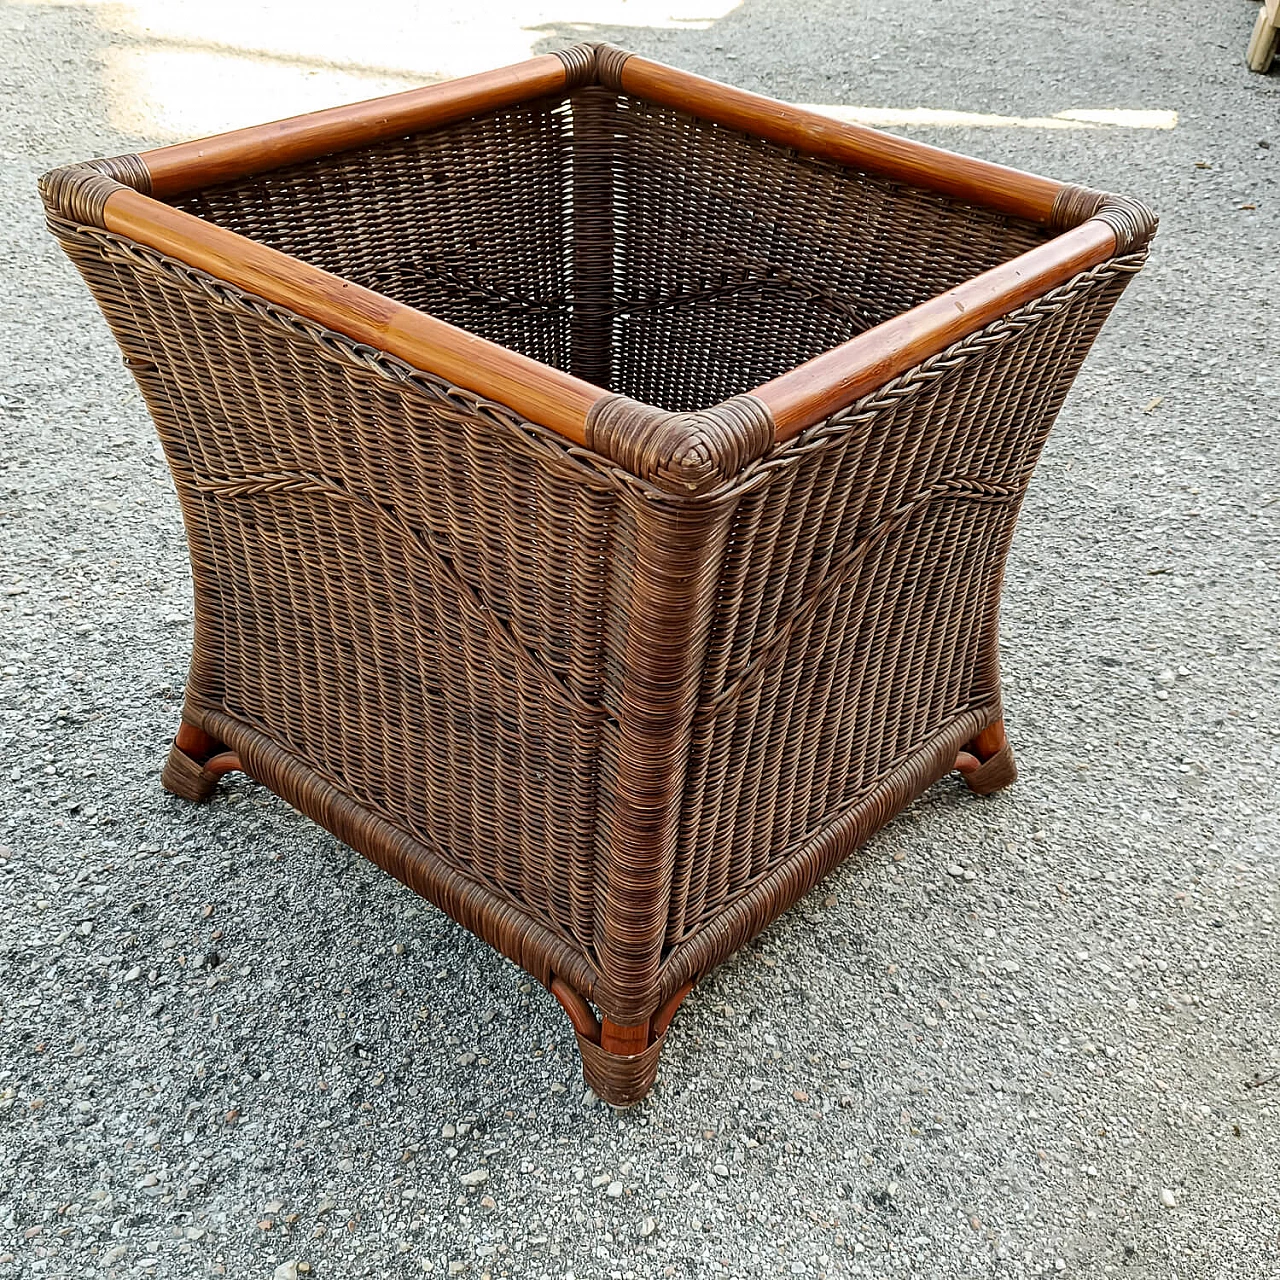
(611, 95, 1048, 410)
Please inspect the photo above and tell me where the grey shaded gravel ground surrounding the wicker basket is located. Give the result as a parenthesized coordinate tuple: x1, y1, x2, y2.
(0, 0, 1280, 1280)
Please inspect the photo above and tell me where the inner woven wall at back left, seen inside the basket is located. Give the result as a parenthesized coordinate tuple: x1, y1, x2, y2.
(174, 100, 572, 369)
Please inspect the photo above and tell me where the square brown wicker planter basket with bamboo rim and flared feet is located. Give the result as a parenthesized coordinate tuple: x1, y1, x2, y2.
(42, 46, 1155, 1103)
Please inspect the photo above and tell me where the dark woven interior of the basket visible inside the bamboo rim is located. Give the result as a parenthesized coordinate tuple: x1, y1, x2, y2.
(173, 88, 1051, 410)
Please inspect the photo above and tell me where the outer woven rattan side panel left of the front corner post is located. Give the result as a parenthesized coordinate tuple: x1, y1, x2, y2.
(54, 225, 639, 983)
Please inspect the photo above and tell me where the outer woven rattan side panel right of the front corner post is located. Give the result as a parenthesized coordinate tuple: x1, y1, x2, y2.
(667, 260, 1138, 962)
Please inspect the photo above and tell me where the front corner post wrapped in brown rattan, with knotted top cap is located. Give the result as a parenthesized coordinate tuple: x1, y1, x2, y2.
(588, 396, 773, 1027)
